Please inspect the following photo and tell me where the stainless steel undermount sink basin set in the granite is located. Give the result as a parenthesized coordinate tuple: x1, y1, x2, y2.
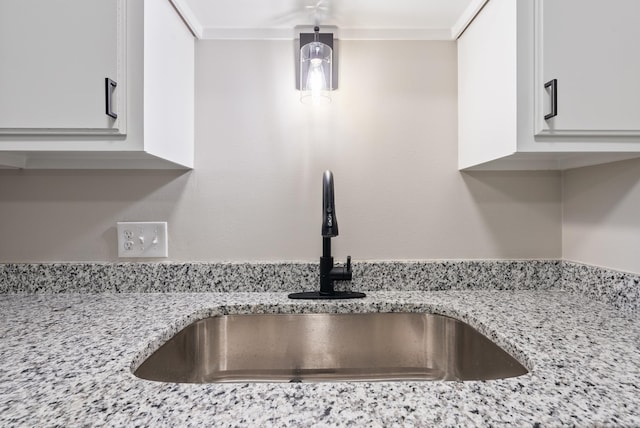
(134, 313, 527, 383)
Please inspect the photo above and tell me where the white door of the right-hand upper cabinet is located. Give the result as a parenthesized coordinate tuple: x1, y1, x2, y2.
(535, 0, 640, 136)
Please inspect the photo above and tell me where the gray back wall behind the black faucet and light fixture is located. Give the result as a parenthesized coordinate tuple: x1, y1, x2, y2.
(0, 41, 560, 262)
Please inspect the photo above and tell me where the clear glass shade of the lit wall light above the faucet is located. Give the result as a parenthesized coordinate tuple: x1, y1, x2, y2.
(300, 41, 333, 104)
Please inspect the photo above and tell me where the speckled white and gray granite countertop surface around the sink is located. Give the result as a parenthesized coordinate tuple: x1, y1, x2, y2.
(0, 290, 640, 427)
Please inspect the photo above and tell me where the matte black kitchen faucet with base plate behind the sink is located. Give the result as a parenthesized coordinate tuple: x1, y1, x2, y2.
(289, 171, 365, 299)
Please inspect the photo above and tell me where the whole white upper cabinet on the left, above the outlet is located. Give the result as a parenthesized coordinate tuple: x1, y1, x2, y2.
(0, 0, 195, 169)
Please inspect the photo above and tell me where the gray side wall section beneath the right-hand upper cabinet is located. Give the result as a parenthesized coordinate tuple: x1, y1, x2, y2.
(562, 159, 640, 273)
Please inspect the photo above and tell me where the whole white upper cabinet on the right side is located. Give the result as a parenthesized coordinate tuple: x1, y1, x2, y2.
(458, 0, 640, 170)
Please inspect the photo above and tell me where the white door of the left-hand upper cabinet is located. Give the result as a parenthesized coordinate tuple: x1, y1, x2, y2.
(0, 0, 125, 134)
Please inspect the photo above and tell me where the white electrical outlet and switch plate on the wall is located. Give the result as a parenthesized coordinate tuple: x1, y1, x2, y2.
(118, 221, 169, 257)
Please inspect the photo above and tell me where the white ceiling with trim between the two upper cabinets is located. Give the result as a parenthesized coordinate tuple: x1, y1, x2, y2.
(171, 0, 488, 40)
